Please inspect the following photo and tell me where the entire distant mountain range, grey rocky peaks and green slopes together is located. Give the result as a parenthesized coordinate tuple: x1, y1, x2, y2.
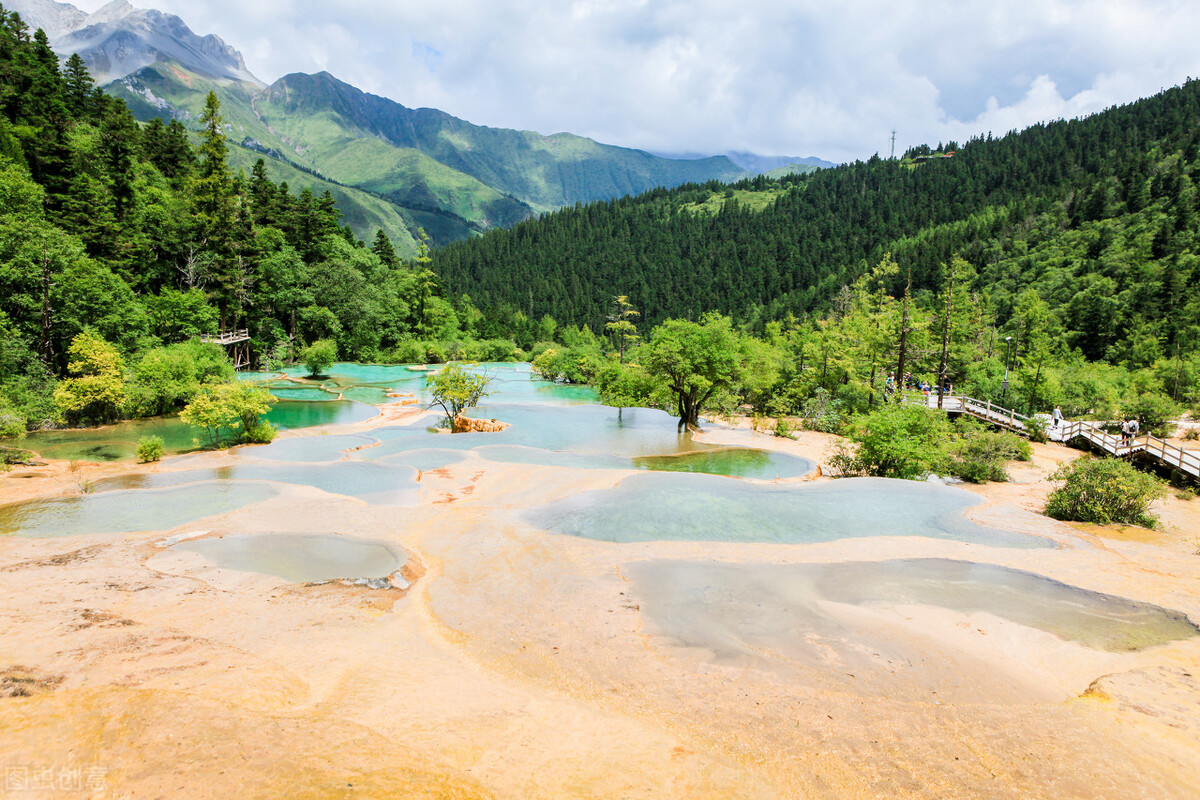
(5, 0, 832, 253)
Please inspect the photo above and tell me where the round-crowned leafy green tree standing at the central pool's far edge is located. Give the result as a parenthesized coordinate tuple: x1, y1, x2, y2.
(638, 313, 743, 427)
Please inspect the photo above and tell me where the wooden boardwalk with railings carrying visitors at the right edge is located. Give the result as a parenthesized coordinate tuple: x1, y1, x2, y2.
(904, 392, 1200, 481)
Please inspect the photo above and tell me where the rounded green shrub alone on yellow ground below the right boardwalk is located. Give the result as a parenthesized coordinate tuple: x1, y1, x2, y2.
(1045, 456, 1166, 528)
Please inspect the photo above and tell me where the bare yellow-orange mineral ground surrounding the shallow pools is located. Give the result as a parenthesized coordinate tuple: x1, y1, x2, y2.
(0, 409, 1200, 799)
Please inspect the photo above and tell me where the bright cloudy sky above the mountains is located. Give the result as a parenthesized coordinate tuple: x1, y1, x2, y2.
(74, 0, 1200, 161)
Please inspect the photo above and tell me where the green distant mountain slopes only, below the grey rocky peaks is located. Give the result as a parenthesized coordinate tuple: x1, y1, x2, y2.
(106, 61, 745, 251)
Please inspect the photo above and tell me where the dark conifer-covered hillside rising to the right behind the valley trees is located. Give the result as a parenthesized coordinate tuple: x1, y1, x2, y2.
(434, 82, 1200, 359)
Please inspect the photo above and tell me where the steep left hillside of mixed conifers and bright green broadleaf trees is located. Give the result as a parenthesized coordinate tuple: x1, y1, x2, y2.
(0, 10, 518, 437)
